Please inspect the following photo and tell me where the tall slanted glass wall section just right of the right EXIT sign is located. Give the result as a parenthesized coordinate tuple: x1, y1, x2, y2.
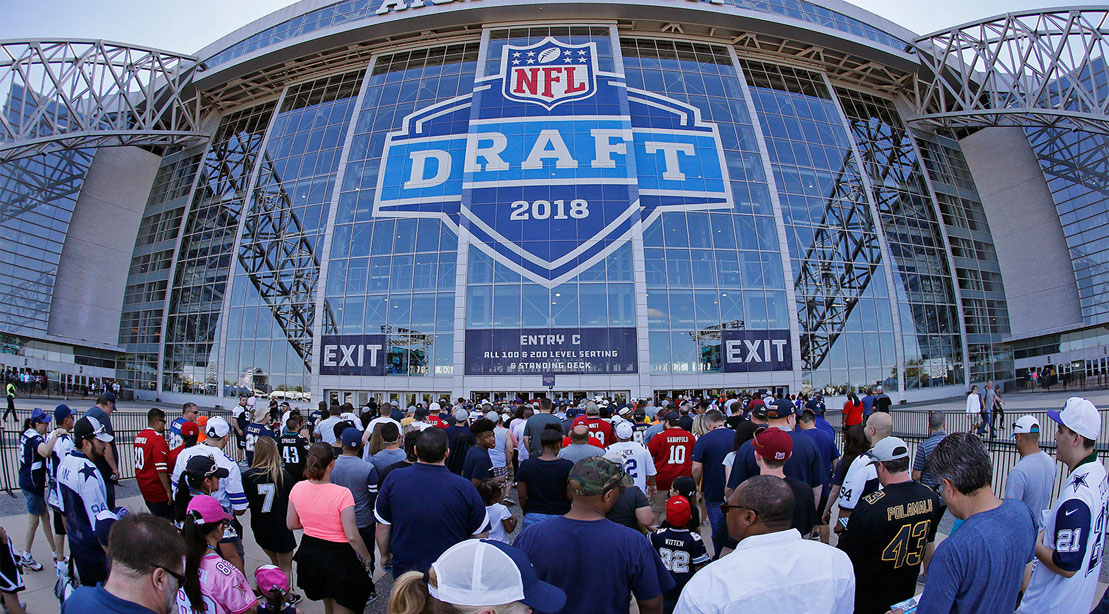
(742, 61, 898, 393)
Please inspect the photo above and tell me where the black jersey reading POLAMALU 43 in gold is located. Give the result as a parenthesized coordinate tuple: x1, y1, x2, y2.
(840, 482, 944, 614)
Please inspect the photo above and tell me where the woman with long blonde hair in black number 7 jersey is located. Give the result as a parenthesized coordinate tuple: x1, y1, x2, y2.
(243, 430, 301, 603)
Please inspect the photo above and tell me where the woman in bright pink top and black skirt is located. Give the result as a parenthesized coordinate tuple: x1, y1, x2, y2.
(285, 441, 374, 614)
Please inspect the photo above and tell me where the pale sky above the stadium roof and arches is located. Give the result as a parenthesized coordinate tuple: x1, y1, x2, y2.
(0, 0, 1074, 54)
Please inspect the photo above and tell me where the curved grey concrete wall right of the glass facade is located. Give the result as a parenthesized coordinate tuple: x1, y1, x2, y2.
(959, 127, 1082, 338)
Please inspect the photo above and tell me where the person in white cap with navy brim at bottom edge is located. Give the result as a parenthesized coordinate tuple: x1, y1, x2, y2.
(387, 540, 566, 614)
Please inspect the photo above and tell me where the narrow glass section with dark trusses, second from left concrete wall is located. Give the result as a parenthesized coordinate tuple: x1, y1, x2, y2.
(162, 102, 276, 395)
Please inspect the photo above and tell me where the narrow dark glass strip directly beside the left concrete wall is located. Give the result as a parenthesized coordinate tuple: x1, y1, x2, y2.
(120, 152, 200, 390)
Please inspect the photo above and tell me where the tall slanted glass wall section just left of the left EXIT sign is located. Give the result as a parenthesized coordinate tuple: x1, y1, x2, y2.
(223, 71, 365, 396)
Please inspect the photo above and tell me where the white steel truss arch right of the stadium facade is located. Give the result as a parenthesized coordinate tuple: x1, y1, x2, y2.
(908, 7, 1109, 134)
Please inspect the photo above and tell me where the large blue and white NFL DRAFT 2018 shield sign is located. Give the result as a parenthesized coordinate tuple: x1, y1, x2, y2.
(374, 38, 732, 287)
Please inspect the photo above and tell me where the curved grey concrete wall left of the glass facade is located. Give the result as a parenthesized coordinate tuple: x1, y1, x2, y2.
(48, 147, 162, 346)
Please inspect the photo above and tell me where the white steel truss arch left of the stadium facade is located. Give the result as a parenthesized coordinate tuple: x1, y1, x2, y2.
(0, 40, 205, 163)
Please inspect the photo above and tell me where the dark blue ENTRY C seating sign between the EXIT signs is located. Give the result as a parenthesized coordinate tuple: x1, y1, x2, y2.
(466, 328, 637, 374)
